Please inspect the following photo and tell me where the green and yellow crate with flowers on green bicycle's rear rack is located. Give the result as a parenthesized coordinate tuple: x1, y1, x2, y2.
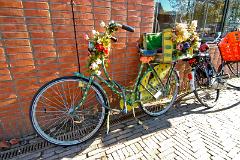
(139, 21, 200, 63)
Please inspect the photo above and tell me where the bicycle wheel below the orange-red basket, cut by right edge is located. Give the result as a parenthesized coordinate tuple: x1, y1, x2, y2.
(218, 62, 240, 89)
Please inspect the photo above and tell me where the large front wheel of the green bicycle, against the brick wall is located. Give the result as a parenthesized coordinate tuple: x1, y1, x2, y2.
(30, 76, 107, 146)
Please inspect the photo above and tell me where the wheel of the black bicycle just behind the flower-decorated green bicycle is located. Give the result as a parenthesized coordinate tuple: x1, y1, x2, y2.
(193, 66, 221, 108)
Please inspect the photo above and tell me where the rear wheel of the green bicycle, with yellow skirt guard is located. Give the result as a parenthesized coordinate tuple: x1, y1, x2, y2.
(139, 66, 179, 117)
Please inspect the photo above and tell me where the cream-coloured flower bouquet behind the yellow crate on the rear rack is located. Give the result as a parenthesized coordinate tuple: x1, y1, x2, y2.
(172, 20, 199, 55)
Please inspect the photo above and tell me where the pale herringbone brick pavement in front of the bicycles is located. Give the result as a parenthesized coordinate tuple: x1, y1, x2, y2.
(0, 86, 240, 160)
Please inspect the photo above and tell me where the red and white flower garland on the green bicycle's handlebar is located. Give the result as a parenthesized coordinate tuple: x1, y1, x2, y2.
(84, 21, 118, 75)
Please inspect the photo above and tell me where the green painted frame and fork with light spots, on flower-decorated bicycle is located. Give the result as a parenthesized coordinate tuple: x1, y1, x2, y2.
(75, 58, 180, 115)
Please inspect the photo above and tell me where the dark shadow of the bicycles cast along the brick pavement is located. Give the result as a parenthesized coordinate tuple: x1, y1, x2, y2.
(3, 88, 240, 159)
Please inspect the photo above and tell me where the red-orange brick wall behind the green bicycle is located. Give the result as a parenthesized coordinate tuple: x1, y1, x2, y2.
(0, 0, 154, 140)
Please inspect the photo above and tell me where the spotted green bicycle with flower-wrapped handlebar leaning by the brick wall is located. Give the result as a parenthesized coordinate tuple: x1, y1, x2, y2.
(30, 21, 179, 146)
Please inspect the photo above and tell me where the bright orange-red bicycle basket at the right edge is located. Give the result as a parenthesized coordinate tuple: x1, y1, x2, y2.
(219, 31, 240, 62)
